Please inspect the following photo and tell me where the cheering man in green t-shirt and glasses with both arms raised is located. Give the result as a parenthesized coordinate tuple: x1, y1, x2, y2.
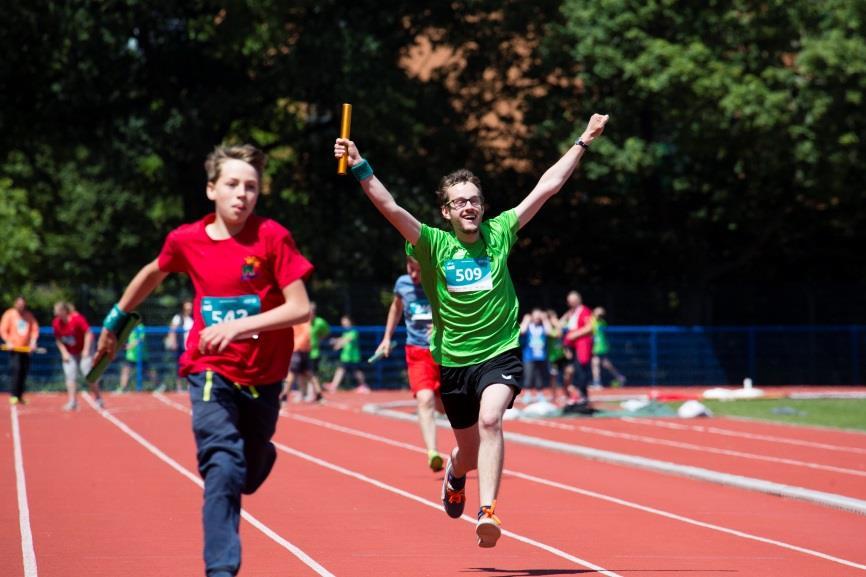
(334, 114, 608, 547)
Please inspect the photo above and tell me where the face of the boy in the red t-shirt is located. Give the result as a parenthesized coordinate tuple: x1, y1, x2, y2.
(207, 158, 259, 225)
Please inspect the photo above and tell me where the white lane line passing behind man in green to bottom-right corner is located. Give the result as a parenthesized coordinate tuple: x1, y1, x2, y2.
(288, 414, 866, 571)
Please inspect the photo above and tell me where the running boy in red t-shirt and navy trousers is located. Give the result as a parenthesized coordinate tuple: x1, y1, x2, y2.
(94, 145, 313, 577)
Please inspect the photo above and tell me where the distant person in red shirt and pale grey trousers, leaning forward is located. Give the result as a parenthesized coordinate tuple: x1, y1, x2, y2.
(51, 302, 102, 411)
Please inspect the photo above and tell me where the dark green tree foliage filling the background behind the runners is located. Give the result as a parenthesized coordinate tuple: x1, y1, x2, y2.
(0, 0, 866, 320)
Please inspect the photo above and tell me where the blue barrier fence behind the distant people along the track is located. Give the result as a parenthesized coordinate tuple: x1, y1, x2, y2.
(0, 325, 866, 390)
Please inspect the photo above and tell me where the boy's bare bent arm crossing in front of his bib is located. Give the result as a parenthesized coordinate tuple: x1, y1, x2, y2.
(198, 280, 310, 353)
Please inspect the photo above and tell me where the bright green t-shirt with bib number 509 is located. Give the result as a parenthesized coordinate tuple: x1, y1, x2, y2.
(406, 210, 520, 367)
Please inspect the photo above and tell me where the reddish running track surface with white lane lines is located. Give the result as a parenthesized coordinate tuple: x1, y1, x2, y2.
(6, 392, 866, 577)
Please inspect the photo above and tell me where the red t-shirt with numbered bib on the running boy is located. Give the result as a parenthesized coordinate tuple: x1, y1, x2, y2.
(158, 214, 313, 385)
